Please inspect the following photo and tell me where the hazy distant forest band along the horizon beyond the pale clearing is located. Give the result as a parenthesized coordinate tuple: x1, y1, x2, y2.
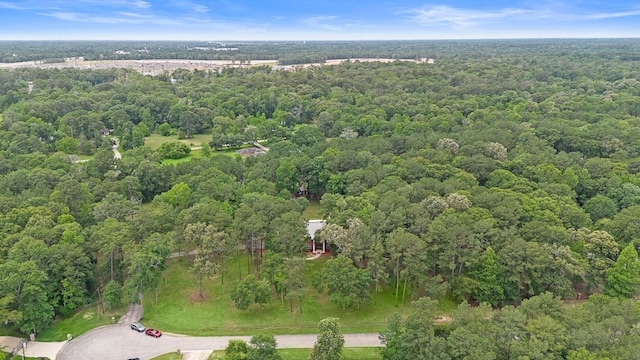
(0, 39, 640, 65)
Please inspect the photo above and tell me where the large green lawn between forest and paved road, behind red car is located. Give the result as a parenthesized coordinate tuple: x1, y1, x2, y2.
(143, 256, 410, 336)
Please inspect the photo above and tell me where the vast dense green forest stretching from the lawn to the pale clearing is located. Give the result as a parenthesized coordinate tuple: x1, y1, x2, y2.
(0, 40, 640, 359)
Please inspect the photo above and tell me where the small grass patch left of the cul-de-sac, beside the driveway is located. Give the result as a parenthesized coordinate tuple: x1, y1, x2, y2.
(36, 305, 126, 341)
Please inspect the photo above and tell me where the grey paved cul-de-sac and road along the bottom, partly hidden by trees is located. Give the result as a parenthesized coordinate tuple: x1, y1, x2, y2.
(57, 324, 381, 360)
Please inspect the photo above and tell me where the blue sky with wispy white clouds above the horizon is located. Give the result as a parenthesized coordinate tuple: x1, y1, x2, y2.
(0, 0, 640, 40)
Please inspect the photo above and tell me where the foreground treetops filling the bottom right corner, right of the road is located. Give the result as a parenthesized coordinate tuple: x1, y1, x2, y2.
(380, 293, 640, 360)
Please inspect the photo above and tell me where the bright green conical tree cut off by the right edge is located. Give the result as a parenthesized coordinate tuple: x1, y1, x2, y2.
(604, 244, 640, 299)
